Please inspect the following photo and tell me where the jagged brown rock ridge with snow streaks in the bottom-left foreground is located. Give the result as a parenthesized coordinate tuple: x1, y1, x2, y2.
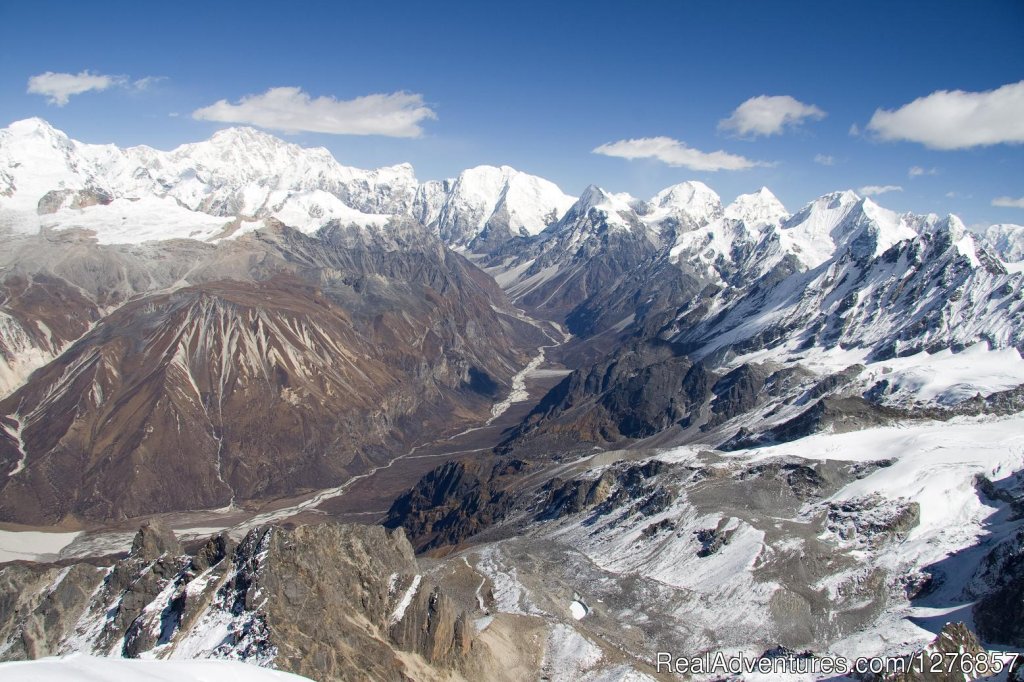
(0, 524, 471, 680)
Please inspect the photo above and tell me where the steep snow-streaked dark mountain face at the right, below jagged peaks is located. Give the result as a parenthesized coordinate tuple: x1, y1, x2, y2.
(665, 212, 1024, 358)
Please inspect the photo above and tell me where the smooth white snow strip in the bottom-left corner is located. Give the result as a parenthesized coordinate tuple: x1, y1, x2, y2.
(0, 654, 308, 682)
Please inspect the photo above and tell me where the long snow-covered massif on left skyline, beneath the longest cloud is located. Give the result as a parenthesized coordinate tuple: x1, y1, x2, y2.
(0, 119, 428, 243)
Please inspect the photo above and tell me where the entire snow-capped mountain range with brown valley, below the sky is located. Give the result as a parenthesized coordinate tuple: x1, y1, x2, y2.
(0, 119, 1024, 679)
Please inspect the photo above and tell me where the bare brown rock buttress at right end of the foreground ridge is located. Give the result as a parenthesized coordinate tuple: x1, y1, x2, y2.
(253, 526, 470, 679)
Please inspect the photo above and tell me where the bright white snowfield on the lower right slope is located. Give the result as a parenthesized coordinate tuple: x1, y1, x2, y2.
(731, 415, 1024, 657)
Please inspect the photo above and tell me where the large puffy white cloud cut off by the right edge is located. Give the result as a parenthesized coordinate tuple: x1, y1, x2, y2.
(867, 81, 1024, 150)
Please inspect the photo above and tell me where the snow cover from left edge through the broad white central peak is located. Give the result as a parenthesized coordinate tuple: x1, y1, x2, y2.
(0, 119, 574, 246)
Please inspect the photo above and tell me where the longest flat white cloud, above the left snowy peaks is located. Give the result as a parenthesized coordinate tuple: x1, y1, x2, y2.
(193, 87, 437, 137)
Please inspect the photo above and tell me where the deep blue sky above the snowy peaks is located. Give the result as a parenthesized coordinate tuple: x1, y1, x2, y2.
(0, 0, 1024, 223)
